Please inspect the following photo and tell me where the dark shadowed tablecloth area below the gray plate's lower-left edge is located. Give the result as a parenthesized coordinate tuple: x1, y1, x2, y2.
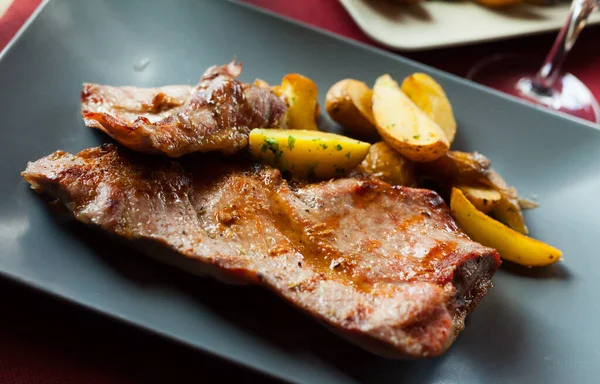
(0, 279, 280, 384)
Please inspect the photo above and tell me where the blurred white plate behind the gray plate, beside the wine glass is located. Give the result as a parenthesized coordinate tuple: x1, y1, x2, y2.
(340, 0, 600, 51)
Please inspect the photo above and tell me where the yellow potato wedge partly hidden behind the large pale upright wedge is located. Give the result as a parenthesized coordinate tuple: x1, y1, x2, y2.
(402, 73, 456, 144)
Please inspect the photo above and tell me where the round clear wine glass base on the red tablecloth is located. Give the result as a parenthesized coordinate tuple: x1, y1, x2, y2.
(467, 55, 600, 123)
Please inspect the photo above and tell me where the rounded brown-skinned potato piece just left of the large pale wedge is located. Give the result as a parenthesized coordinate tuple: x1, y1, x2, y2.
(325, 79, 377, 137)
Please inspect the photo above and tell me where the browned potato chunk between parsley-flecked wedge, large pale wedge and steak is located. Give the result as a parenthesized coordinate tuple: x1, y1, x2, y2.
(356, 141, 417, 187)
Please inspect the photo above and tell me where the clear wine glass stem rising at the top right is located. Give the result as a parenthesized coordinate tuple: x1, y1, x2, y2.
(533, 0, 598, 92)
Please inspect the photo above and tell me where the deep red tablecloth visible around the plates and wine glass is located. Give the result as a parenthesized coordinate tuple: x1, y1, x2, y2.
(0, 0, 600, 384)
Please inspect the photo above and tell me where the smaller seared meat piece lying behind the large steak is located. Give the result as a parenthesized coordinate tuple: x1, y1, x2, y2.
(81, 62, 287, 157)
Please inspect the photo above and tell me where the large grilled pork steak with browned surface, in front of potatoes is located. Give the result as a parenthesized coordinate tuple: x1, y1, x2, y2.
(23, 145, 500, 358)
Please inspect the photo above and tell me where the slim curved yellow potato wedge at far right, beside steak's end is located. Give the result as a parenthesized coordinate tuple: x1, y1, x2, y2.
(450, 188, 562, 267)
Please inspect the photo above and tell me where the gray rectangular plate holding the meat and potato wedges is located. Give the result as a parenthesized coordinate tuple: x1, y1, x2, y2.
(0, 0, 600, 383)
